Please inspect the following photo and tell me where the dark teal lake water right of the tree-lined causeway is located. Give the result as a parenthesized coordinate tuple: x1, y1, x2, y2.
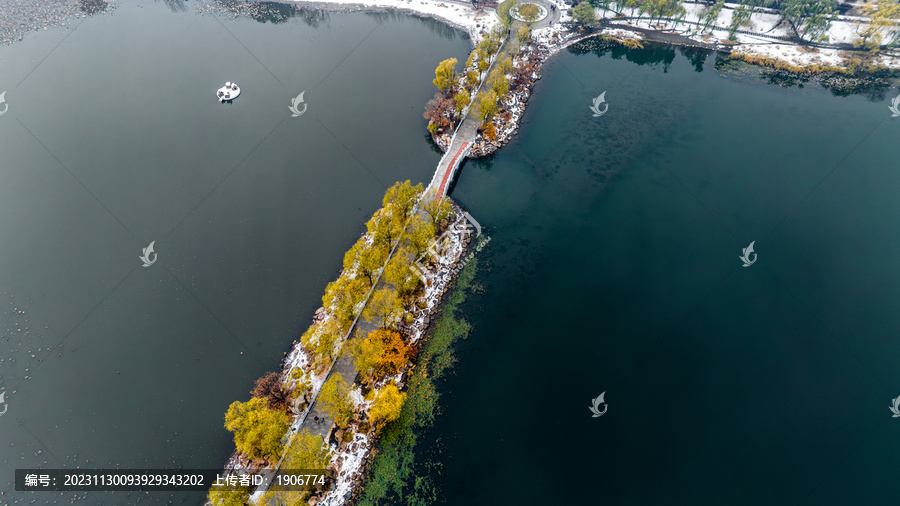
(434, 45, 900, 505)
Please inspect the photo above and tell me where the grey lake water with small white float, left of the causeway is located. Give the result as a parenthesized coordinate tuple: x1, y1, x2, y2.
(0, 2, 469, 504)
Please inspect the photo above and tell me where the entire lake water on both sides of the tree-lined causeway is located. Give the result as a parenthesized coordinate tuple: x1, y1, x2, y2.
(0, 3, 900, 505)
